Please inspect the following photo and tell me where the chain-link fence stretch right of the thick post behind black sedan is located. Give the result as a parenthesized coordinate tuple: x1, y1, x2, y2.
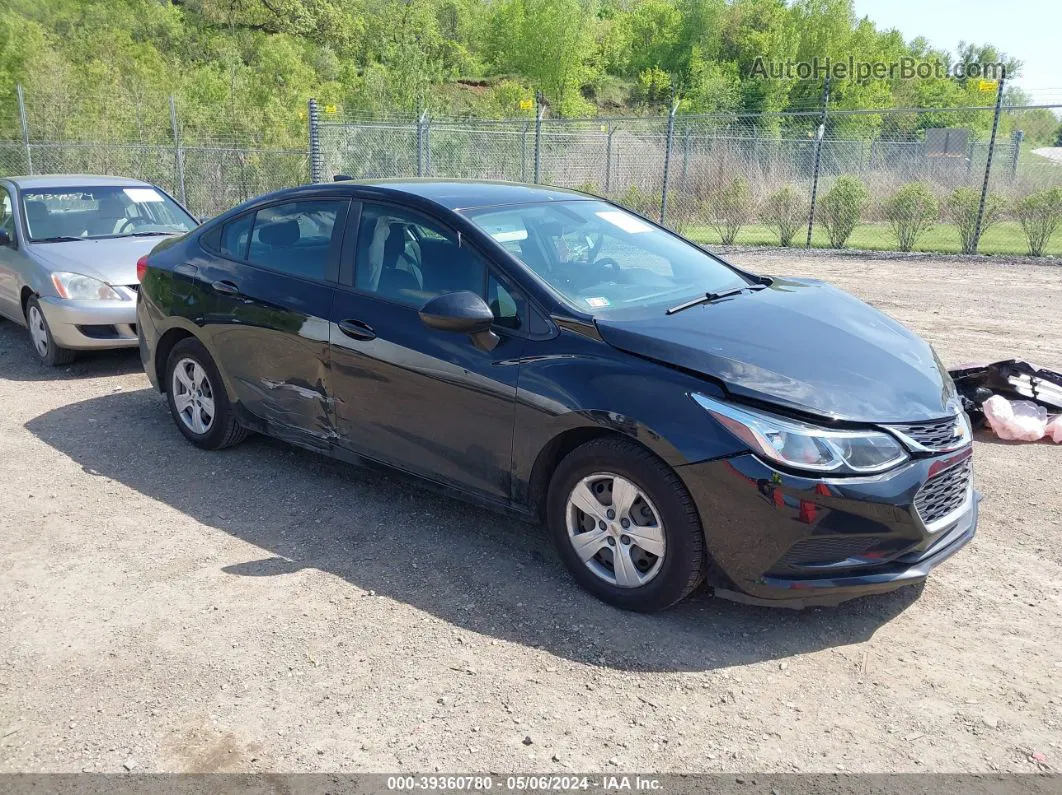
(316, 97, 1062, 255)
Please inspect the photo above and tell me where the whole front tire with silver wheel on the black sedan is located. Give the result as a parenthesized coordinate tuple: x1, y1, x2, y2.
(546, 437, 707, 612)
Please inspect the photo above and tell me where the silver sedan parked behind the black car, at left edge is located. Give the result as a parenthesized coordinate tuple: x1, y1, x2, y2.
(0, 175, 196, 366)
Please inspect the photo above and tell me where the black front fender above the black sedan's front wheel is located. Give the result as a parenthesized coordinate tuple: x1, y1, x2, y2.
(513, 330, 744, 501)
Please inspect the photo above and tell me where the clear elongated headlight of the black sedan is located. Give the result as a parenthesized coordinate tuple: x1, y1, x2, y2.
(691, 393, 908, 474)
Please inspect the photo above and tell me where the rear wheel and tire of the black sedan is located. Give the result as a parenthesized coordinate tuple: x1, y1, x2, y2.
(166, 338, 247, 450)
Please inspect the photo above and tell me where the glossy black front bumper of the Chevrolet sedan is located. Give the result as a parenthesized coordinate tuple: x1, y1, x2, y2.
(678, 447, 980, 607)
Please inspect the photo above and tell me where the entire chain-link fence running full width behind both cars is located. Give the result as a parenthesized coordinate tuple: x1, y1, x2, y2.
(0, 87, 1062, 256)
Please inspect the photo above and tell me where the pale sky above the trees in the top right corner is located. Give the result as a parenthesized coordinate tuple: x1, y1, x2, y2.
(854, 0, 1062, 104)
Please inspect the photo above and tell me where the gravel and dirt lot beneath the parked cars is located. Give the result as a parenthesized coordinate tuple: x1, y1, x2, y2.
(0, 254, 1062, 772)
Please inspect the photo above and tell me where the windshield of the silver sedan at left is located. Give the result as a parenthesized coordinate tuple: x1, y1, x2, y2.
(22, 186, 196, 242)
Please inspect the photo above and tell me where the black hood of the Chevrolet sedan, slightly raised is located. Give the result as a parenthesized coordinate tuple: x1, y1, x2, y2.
(597, 279, 956, 422)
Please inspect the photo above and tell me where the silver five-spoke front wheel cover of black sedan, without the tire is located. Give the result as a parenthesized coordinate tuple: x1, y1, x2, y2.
(565, 472, 667, 588)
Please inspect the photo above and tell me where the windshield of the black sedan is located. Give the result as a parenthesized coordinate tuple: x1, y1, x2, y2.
(468, 201, 748, 315)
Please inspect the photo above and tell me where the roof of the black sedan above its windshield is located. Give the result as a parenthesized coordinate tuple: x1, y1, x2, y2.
(337, 179, 595, 210)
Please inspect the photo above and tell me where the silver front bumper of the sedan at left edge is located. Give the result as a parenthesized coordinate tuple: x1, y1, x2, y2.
(40, 297, 137, 350)
